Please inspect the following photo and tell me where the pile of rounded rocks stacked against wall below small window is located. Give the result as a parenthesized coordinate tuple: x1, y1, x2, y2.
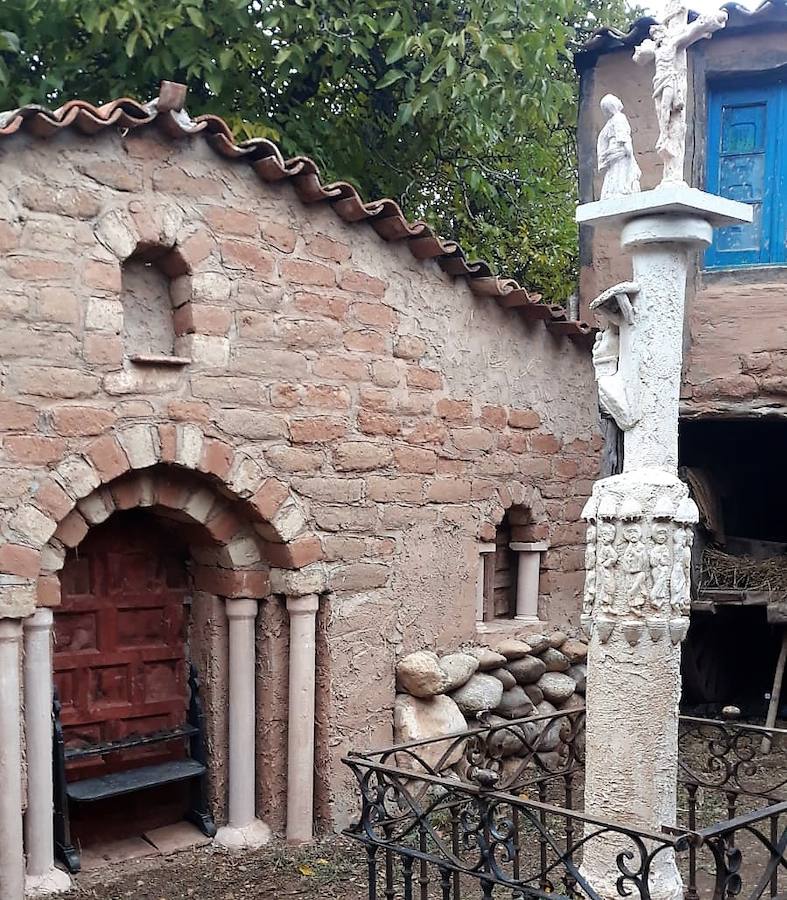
(394, 631, 587, 762)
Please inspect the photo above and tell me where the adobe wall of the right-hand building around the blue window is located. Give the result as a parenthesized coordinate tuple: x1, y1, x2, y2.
(580, 26, 787, 414)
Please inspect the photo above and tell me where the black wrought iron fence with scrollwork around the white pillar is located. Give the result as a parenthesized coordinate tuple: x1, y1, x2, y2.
(344, 710, 787, 900)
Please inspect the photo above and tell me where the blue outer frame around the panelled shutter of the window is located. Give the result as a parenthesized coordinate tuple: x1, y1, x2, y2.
(703, 73, 787, 272)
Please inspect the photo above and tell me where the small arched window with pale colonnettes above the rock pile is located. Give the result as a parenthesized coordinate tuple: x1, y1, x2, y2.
(476, 506, 549, 623)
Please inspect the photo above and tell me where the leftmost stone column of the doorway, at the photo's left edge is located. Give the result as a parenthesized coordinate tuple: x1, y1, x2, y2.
(0, 619, 24, 900)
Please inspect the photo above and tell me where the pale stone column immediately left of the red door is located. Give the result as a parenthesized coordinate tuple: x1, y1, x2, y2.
(24, 607, 71, 896)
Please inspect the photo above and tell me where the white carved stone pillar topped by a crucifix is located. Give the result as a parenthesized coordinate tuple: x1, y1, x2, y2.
(577, 0, 752, 900)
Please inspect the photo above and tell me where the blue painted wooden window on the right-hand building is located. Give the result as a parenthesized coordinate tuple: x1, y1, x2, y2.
(705, 83, 787, 268)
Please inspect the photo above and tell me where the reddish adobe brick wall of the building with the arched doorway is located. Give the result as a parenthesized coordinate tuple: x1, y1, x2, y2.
(0, 129, 600, 828)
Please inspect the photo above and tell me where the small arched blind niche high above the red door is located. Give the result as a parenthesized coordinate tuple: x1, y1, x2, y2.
(121, 247, 190, 366)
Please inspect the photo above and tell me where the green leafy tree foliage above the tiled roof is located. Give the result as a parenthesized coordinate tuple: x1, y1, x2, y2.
(0, 0, 632, 300)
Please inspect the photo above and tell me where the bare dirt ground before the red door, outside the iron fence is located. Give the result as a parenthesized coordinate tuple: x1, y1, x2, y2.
(63, 837, 368, 900)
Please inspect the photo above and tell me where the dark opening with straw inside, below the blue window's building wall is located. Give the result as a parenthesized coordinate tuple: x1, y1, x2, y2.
(679, 417, 787, 720)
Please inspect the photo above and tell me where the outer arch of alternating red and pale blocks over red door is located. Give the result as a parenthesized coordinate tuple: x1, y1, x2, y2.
(0, 424, 322, 617)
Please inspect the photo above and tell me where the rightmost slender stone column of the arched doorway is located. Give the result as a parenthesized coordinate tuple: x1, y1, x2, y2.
(287, 594, 319, 844)
